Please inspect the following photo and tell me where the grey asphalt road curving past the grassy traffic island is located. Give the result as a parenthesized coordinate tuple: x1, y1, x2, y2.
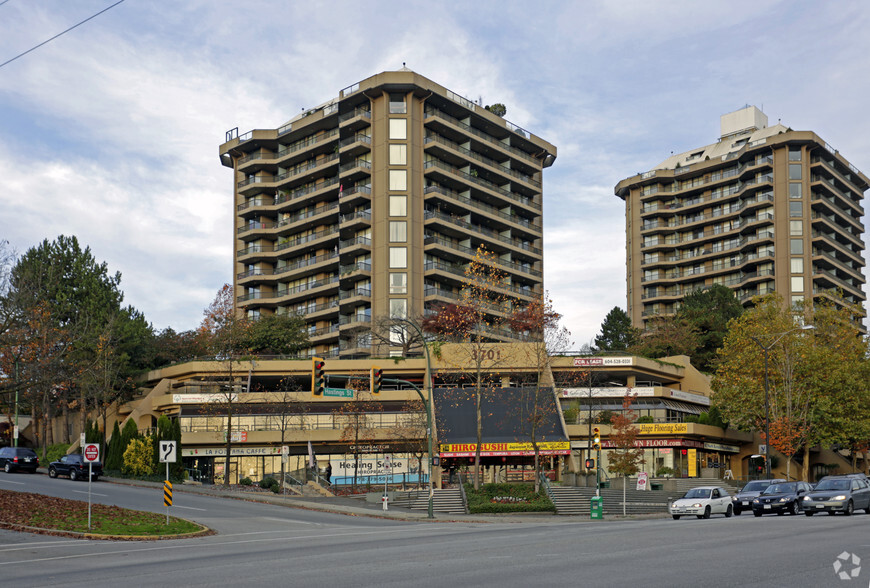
(0, 474, 870, 588)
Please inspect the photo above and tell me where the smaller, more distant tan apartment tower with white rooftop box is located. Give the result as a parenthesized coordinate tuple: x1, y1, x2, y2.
(616, 106, 870, 326)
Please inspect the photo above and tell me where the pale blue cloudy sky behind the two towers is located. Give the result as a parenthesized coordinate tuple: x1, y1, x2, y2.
(0, 0, 870, 348)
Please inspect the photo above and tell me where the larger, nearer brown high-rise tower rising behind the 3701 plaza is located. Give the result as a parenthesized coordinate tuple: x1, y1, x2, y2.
(220, 68, 556, 357)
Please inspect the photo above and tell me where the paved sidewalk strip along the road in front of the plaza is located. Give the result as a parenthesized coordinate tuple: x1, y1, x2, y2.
(100, 477, 669, 524)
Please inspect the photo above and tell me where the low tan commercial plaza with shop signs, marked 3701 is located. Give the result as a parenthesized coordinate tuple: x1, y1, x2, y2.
(118, 343, 772, 483)
